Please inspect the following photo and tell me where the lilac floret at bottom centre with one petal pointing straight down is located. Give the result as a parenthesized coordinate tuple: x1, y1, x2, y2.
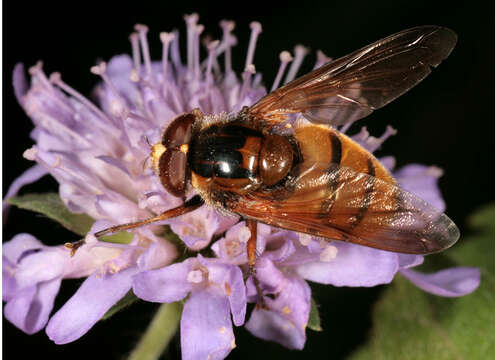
(133, 255, 246, 359)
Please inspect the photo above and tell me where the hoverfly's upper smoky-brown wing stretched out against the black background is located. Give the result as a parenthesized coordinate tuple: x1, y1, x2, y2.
(249, 26, 457, 126)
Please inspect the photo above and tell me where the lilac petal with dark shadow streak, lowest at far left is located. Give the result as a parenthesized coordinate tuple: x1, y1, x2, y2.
(4, 278, 61, 334)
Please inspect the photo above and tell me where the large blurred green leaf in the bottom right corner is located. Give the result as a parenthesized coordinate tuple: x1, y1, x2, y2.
(351, 205, 495, 360)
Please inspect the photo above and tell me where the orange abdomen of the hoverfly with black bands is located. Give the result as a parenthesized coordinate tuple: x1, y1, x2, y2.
(289, 125, 398, 231)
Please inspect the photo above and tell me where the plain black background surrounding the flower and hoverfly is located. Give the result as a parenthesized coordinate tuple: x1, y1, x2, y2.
(3, 0, 495, 359)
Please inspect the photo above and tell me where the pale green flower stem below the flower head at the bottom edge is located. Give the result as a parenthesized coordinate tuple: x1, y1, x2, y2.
(129, 302, 182, 360)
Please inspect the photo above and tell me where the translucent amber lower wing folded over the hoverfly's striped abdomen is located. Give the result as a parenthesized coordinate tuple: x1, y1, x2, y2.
(229, 164, 459, 254)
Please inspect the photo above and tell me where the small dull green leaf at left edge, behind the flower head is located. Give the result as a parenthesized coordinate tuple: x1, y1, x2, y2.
(7, 193, 94, 235)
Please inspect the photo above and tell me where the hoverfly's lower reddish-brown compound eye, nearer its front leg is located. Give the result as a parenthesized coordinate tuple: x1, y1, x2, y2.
(159, 150, 187, 197)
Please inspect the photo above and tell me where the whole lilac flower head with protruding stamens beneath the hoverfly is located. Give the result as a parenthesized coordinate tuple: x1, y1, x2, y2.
(3, 14, 480, 359)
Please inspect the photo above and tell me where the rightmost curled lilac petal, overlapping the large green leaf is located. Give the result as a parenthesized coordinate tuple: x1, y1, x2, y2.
(400, 267, 481, 297)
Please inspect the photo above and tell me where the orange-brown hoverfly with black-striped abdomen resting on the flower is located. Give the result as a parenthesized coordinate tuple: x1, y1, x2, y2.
(90, 26, 459, 276)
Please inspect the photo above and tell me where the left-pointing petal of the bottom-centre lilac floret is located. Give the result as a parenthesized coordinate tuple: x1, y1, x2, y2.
(132, 260, 192, 303)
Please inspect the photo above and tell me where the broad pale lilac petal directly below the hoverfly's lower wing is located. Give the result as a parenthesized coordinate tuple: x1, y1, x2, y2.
(296, 241, 399, 287)
